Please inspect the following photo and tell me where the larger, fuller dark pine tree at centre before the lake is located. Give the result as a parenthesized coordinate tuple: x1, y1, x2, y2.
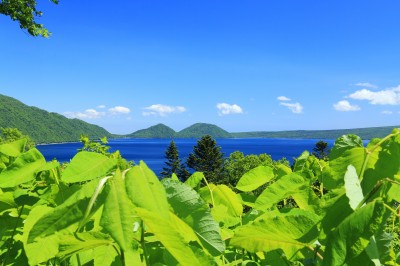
(186, 135, 224, 184)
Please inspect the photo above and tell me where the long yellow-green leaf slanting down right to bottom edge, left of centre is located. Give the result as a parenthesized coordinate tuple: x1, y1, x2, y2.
(135, 208, 213, 265)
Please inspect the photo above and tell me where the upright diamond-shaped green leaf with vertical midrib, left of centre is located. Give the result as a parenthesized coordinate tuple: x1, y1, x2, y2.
(100, 170, 135, 251)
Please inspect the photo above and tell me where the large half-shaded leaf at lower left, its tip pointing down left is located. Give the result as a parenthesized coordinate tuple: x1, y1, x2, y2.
(28, 180, 104, 243)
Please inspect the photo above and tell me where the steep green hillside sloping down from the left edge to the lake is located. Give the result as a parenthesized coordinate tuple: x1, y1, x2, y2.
(0, 94, 111, 143)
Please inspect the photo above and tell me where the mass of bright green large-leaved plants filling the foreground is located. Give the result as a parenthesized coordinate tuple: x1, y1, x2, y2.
(0, 129, 400, 265)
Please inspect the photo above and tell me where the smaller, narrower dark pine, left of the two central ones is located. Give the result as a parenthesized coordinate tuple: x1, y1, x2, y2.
(160, 140, 190, 181)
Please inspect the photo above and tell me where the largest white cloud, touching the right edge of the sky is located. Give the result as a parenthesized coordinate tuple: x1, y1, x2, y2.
(348, 86, 400, 105)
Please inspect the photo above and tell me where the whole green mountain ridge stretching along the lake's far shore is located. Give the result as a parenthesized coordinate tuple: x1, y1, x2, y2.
(0, 94, 400, 143)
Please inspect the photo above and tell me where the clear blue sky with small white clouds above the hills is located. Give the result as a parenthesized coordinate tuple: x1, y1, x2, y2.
(0, 0, 400, 133)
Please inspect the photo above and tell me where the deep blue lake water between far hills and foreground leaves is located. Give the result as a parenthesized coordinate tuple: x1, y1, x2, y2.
(37, 138, 334, 175)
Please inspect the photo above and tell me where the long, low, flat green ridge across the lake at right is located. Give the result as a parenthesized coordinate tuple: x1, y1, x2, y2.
(231, 126, 400, 139)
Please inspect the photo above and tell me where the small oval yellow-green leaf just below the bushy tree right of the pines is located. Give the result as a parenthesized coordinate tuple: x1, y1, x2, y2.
(236, 165, 274, 192)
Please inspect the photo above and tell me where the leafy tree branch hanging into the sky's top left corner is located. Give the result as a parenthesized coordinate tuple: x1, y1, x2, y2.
(0, 0, 58, 38)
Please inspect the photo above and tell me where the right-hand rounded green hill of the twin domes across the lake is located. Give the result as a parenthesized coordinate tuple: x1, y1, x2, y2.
(175, 123, 232, 138)
